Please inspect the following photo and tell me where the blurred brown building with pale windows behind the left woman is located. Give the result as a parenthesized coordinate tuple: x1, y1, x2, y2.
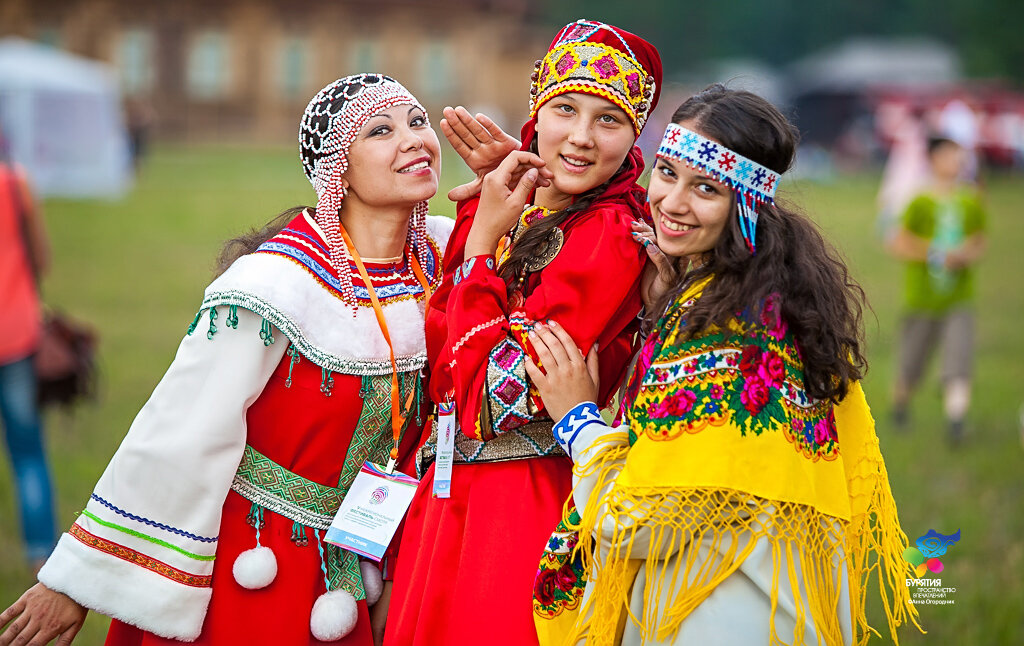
(0, 0, 548, 141)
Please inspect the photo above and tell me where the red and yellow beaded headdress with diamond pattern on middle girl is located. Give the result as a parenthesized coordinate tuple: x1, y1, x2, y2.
(529, 20, 654, 135)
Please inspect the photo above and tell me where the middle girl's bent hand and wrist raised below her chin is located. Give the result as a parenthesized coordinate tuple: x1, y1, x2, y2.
(465, 150, 544, 258)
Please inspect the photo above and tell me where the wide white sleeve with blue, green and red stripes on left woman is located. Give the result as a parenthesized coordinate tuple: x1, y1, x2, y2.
(39, 308, 287, 640)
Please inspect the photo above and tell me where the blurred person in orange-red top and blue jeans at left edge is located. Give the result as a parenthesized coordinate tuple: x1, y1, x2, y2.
(0, 124, 56, 570)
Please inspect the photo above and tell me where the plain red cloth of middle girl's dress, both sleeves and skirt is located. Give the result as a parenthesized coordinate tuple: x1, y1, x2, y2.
(385, 199, 644, 646)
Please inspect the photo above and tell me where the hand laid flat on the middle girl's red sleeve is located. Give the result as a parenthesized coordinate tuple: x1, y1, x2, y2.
(526, 320, 600, 422)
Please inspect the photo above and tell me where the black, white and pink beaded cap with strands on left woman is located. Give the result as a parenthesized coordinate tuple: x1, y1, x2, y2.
(299, 74, 428, 311)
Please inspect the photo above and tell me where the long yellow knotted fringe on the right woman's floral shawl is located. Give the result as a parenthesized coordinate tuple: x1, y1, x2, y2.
(566, 437, 925, 646)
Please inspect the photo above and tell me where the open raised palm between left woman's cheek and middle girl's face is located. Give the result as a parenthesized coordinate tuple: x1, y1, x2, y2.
(440, 105, 551, 202)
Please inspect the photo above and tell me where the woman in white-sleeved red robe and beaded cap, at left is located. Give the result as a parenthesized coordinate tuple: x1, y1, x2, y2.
(0, 75, 452, 646)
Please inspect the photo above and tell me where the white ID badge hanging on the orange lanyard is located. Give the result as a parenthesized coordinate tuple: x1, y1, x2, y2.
(324, 462, 419, 561)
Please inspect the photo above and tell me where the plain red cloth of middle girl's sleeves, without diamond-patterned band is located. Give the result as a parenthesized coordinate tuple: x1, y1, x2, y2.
(427, 199, 645, 435)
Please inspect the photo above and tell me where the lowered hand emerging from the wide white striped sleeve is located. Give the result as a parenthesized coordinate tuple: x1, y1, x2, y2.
(0, 584, 87, 646)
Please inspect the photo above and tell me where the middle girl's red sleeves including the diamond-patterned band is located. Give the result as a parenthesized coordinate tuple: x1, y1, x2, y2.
(444, 203, 644, 440)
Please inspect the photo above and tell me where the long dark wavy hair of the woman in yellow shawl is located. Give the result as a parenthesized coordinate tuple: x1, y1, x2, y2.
(649, 84, 867, 401)
